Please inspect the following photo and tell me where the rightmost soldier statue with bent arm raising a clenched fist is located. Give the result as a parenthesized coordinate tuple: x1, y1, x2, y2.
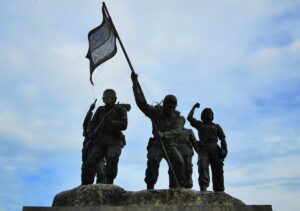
(187, 103, 228, 191)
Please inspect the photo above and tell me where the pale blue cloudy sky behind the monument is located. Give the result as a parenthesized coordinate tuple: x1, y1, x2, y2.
(0, 0, 300, 211)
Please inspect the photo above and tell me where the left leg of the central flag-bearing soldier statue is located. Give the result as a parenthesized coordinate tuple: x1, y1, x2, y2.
(145, 144, 163, 190)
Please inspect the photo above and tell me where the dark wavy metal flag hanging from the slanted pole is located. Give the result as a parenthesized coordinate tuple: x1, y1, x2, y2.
(86, 6, 117, 85)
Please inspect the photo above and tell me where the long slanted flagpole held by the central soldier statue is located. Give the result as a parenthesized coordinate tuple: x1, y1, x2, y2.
(102, 2, 180, 187)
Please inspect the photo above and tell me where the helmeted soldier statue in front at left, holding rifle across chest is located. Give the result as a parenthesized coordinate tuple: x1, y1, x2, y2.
(82, 89, 130, 185)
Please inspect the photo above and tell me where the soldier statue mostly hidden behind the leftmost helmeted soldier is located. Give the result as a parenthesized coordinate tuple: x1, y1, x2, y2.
(81, 99, 105, 183)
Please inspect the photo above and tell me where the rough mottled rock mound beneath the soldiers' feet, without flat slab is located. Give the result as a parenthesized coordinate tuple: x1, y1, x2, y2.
(52, 184, 245, 207)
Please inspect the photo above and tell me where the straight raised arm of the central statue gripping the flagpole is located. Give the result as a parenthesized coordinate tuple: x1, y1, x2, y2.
(131, 72, 150, 116)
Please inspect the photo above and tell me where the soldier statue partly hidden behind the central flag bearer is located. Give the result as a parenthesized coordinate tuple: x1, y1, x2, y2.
(168, 116, 198, 188)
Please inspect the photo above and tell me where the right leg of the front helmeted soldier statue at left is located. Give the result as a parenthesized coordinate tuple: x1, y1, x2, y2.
(105, 144, 122, 184)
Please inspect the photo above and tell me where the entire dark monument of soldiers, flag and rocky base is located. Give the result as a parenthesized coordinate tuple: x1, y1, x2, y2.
(23, 3, 272, 211)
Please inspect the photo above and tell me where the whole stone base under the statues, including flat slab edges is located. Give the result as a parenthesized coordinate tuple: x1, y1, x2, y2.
(23, 184, 272, 211)
